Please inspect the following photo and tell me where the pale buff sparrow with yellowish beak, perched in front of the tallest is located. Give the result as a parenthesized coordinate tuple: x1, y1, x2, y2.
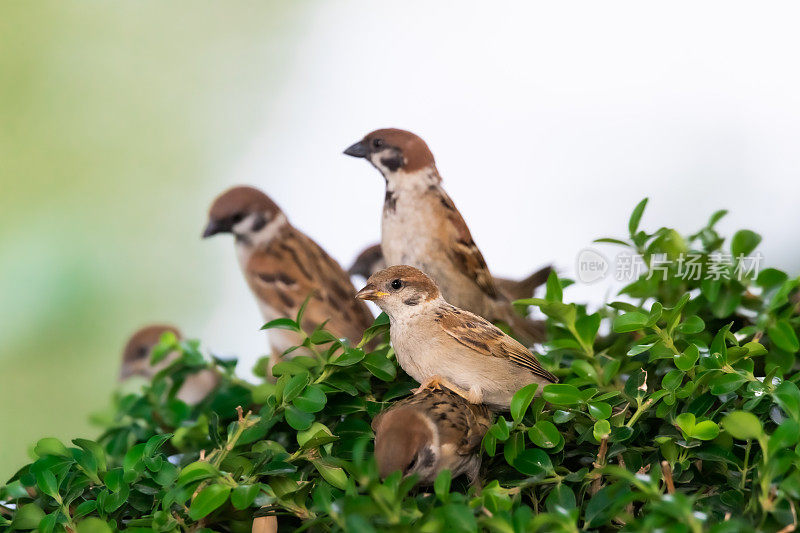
(356, 265, 558, 410)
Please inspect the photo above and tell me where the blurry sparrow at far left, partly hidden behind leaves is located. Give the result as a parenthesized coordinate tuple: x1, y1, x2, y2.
(119, 324, 219, 405)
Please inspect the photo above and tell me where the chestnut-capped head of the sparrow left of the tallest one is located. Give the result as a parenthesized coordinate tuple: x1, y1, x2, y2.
(203, 187, 286, 244)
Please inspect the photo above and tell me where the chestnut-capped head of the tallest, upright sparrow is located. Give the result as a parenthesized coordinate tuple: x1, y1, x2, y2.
(344, 128, 435, 177)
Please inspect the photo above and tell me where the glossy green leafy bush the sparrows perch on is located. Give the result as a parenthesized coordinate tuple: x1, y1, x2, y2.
(0, 197, 800, 533)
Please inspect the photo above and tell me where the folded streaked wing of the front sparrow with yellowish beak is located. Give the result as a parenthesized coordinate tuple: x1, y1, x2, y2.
(435, 306, 558, 383)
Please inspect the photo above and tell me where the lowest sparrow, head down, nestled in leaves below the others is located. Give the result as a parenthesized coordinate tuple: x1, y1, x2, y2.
(372, 380, 492, 485)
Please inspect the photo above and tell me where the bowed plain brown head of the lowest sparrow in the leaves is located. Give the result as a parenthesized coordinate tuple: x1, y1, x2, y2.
(375, 407, 438, 480)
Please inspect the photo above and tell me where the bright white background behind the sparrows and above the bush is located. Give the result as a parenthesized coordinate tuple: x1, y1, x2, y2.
(195, 2, 800, 372)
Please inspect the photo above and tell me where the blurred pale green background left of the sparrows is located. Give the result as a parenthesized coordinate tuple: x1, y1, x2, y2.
(0, 1, 303, 480)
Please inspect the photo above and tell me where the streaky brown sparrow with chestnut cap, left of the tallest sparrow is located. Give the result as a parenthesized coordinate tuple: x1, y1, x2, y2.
(203, 187, 374, 363)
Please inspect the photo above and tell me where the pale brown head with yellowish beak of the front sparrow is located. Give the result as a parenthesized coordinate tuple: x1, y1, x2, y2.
(356, 265, 441, 317)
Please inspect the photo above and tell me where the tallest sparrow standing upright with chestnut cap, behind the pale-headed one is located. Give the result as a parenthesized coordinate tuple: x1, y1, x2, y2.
(344, 129, 545, 343)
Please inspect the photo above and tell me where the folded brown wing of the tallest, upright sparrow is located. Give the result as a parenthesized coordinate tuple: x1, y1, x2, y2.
(437, 188, 497, 298)
